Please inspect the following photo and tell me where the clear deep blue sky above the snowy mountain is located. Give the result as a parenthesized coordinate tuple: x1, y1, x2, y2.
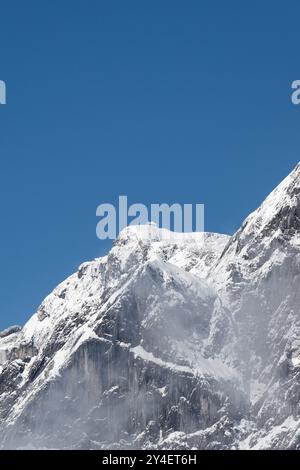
(0, 0, 300, 328)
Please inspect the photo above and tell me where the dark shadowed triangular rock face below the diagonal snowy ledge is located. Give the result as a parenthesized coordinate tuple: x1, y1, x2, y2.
(4, 340, 244, 448)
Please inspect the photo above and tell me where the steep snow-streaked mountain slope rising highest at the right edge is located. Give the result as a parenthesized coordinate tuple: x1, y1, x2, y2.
(210, 165, 300, 448)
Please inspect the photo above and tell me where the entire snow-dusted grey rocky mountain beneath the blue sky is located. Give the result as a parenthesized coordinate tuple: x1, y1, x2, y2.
(0, 166, 300, 449)
